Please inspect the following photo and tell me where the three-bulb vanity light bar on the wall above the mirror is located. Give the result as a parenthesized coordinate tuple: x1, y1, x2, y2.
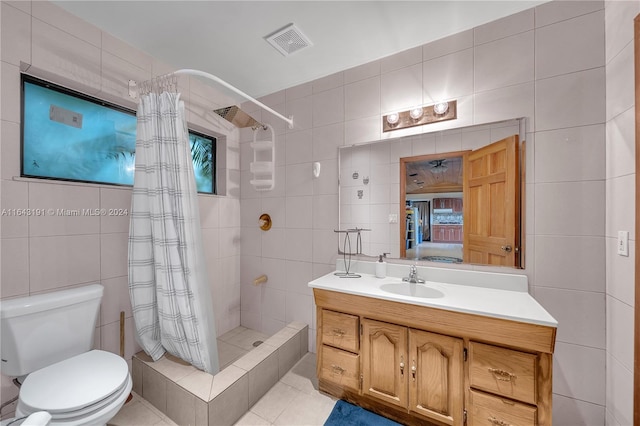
(382, 100, 458, 132)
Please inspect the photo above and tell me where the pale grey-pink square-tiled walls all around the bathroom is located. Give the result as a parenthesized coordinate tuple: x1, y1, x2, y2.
(0, 0, 639, 424)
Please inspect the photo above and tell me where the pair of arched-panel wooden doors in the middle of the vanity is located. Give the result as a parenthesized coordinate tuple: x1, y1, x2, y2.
(362, 318, 463, 424)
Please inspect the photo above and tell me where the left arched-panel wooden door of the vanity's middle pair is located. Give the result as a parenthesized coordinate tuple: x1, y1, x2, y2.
(361, 319, 409, 408)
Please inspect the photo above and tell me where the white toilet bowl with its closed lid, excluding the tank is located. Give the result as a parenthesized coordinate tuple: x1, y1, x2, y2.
(15, 350, 132, 426)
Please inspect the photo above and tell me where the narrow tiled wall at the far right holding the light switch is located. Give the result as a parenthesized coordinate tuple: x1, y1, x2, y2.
(605, 1, 640, 425)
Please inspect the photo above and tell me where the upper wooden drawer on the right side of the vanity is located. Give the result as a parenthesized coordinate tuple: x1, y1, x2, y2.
(469, 342, 537, 404)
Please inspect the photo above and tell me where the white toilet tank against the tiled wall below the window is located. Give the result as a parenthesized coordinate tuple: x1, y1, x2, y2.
(0, 284, 104, 377)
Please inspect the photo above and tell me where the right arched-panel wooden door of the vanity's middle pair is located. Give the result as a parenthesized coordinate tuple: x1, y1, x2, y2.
(407, 329, 464, 425)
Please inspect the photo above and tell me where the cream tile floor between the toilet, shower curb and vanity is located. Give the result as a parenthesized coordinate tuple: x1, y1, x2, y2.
(109, 352, 336, 426)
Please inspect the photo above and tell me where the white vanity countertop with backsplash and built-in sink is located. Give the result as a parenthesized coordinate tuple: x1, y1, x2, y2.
(309, 261, 558, 327)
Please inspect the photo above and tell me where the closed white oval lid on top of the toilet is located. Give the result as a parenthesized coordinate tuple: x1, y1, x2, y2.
(20, 350, 129, 413)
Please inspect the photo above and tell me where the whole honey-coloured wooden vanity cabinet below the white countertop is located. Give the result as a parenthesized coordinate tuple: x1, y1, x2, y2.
(313, 288, 556, 426)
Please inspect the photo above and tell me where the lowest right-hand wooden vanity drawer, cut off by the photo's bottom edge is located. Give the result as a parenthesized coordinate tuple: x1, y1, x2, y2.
(468, 390, 537, 426)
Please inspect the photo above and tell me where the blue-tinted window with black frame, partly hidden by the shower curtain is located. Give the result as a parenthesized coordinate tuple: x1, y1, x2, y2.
(21, 75, 216, 194)
